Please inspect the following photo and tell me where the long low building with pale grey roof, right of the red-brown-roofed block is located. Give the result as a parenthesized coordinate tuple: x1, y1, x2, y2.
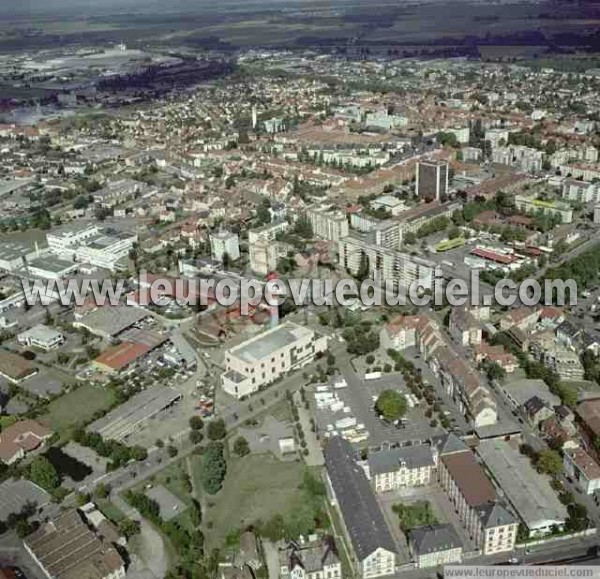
(477, 440, 568, 529)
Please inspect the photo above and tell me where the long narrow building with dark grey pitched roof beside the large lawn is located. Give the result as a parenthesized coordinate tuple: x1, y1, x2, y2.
(324, 436, 397, 561)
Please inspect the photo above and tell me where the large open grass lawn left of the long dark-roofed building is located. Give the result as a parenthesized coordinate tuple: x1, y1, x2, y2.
(202, 454, 304, 547)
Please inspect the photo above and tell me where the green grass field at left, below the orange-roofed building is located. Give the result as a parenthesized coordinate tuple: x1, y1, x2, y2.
(41, 384, 113, 432)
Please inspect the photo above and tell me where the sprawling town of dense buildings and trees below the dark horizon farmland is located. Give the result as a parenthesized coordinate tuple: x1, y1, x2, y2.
(0, 7, 600, 579)
